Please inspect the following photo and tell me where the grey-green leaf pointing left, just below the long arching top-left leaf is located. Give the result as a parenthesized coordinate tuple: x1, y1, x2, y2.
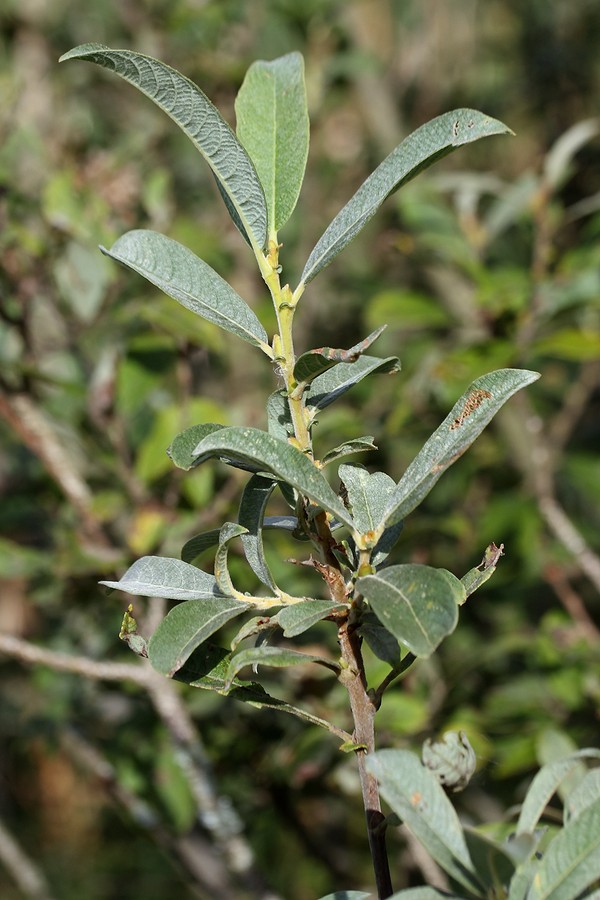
(100, 230, 272, 356)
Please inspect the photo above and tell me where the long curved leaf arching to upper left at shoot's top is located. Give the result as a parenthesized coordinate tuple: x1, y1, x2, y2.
(60, 44, 267, 248)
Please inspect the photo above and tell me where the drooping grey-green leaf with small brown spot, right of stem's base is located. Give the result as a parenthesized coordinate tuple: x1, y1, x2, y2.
(365, 750, 482, 896)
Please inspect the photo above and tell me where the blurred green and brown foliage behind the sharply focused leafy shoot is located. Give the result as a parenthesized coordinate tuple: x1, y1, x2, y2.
(0, 0, 600, 900)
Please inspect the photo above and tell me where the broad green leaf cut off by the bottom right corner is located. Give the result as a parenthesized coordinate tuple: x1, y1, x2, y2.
(527, 800, 600, 900)
